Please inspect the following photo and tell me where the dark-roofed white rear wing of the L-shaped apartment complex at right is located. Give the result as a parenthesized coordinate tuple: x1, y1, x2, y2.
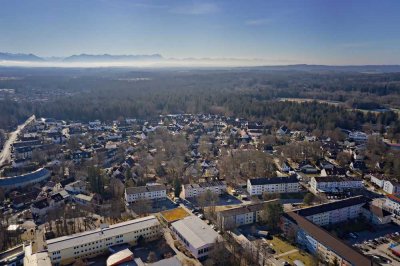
(295, 196, 368, 226)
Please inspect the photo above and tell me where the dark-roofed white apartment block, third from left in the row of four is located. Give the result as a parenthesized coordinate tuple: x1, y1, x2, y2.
(247, 175, 301, 196)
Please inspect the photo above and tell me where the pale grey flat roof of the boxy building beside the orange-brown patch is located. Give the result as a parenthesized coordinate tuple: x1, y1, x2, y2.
(171, 215, 219, 249)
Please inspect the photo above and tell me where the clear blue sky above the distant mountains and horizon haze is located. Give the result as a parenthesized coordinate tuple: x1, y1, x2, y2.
(0, 0, 400, 65)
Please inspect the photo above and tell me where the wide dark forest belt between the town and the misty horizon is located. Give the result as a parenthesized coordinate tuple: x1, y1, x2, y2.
(0, 68, 400, 137)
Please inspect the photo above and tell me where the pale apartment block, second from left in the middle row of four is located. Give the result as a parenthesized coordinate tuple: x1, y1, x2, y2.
(181, 181, 226, 199)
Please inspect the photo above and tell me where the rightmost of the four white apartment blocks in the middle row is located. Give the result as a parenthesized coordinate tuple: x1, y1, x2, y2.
(310, 176, 364, 193)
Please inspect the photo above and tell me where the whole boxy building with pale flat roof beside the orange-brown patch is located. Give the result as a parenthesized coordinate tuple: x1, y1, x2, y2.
(171, 215, 219, 258)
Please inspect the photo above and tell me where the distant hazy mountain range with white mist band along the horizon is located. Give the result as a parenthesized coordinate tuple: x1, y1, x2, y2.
(0, 52, 400, 73)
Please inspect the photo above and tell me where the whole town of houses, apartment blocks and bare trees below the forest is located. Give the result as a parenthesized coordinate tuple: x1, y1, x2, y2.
(0, 111, 400, 265)
